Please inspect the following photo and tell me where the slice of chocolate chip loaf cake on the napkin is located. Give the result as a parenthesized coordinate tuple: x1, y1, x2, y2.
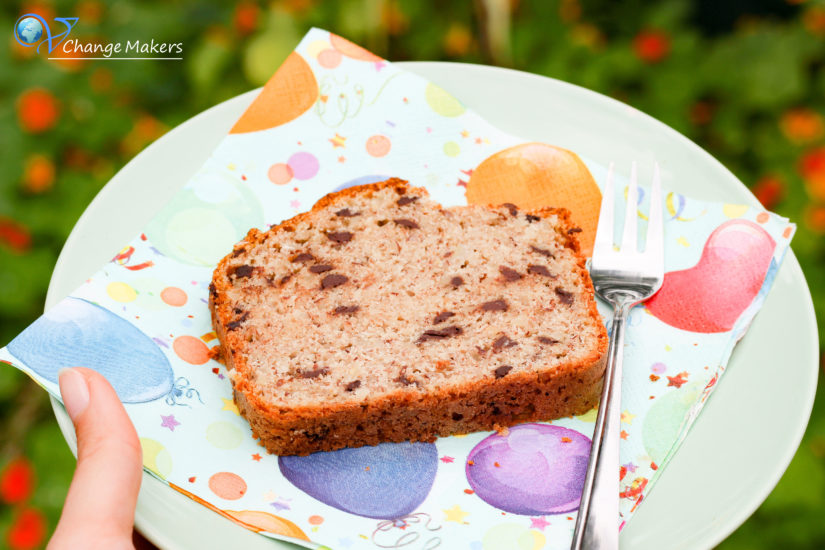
(209, 179, 607, 455)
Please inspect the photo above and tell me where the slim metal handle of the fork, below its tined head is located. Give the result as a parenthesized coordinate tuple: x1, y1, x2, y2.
(570, 296, 633, 550)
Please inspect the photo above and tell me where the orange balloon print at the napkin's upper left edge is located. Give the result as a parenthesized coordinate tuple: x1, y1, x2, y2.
(229, 52, 318, 134)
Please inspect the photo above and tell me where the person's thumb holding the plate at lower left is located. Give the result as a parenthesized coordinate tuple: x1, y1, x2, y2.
(49, 368, 143, 549)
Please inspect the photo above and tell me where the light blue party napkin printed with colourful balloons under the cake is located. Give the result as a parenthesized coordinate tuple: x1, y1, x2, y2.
(0, 29, 794, 550)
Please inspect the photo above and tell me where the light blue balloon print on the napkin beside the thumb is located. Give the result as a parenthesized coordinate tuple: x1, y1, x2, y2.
(8, 297, 174, 403)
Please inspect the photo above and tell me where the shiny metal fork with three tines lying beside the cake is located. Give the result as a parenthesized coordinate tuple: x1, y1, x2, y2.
(571, 162, 664, 550)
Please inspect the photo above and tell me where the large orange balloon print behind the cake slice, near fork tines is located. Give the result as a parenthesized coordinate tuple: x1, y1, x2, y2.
(467, 143, 602, 256)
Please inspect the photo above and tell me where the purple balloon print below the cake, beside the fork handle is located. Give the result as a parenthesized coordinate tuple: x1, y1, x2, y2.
(466, 424, 590, 516)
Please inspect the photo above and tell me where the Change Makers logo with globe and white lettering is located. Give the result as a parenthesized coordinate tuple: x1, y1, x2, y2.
(14, 13, 183, 61)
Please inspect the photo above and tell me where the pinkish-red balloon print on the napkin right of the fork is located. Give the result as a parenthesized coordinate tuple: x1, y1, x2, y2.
(647, 220, 776, 333)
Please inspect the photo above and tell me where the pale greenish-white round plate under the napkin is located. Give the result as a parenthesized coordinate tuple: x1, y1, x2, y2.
(46, 62, 818, 550)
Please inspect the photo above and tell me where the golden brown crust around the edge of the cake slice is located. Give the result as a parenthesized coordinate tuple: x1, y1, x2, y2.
(209, 178, 608, 455)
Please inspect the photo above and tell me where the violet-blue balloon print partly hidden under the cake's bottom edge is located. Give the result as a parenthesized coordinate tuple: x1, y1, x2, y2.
(278, 443, 438, 519)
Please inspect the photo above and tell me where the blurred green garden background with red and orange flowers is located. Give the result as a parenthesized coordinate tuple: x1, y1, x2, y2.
(0, 0, 825, 550)
